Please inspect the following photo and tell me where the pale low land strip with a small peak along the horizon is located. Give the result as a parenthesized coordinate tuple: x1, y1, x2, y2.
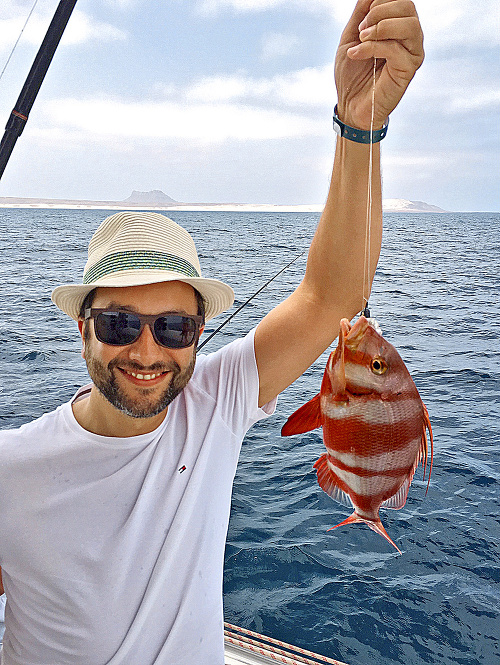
(0, 189, 448, 213)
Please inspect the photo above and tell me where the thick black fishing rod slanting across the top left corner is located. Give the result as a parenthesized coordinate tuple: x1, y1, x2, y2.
(0, 0, 77, 178)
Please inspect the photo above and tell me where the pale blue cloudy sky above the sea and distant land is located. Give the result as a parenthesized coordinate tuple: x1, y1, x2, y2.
(0, 0, 500, 211)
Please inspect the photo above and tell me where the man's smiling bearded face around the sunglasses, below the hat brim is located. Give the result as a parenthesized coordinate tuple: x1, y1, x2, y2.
(80, 282, 198, 418)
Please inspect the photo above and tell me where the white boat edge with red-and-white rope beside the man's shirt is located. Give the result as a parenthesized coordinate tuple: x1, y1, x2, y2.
(224, 623, 347, 665)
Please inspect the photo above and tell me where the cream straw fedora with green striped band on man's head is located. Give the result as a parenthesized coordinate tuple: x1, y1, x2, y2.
(52, 211, 234, 321)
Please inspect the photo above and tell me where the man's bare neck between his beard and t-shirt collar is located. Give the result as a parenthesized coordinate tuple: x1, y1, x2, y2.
(71, 386, 168, 438)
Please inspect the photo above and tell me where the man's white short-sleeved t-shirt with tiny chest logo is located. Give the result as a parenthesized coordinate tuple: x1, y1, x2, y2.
(0, 331, 274, 665)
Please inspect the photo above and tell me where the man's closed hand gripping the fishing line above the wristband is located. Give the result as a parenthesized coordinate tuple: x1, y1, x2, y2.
(335, 0, 424, 129)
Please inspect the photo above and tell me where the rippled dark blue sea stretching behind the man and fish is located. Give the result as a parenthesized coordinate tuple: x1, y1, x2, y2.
(0, 209, 500, 665)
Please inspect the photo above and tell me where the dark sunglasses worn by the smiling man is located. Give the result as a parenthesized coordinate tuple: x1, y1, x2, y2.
(85, 307, 203, 349)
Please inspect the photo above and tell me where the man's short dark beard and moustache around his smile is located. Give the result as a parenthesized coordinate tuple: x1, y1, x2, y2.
(85, 344, 196, 418)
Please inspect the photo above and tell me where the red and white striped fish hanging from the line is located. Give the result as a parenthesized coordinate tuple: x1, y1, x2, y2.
(281, 316, 433, 552)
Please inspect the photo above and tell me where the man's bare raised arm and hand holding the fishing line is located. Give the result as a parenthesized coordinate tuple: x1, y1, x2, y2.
(255, 0, 424, 405)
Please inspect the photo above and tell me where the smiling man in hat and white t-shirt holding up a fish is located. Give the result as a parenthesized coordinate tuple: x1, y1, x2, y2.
(0, 0, 423, 665)
